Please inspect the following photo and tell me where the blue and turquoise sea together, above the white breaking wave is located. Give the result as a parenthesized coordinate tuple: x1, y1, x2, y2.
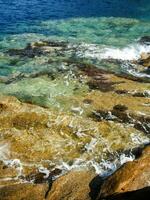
(0, 0, 150, 41)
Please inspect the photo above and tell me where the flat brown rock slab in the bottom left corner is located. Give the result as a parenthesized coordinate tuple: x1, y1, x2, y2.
(0, 183, 48, 200)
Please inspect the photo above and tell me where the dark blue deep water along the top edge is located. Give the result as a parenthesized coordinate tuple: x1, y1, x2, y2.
(0, 0, 150, 33)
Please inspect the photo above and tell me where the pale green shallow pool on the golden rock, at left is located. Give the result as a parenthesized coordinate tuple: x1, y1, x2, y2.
(0, 77, 88, 109)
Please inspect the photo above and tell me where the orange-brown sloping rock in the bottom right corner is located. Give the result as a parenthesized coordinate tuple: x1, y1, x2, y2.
(98, 146, 150, 199)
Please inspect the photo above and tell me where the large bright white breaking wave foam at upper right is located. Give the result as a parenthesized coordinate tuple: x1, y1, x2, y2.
(73, 41, 150, 78)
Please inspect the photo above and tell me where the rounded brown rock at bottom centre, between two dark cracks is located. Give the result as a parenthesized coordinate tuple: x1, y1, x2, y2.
(47, 171, 95, 200)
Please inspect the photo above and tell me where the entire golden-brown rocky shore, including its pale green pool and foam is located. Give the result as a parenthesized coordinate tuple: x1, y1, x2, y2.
(0, 38, 150, 200)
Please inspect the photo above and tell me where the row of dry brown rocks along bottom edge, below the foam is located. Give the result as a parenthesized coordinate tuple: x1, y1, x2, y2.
(0, 146, 150, 200)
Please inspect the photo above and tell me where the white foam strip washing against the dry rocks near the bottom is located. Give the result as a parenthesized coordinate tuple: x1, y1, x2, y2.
(0, 129, 150, 182)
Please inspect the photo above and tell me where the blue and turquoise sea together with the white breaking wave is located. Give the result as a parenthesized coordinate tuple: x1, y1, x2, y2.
(0, 0, 150, 76)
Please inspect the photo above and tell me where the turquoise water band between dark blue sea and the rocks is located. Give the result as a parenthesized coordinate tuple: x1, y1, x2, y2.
(0, 17, 150, 48)
